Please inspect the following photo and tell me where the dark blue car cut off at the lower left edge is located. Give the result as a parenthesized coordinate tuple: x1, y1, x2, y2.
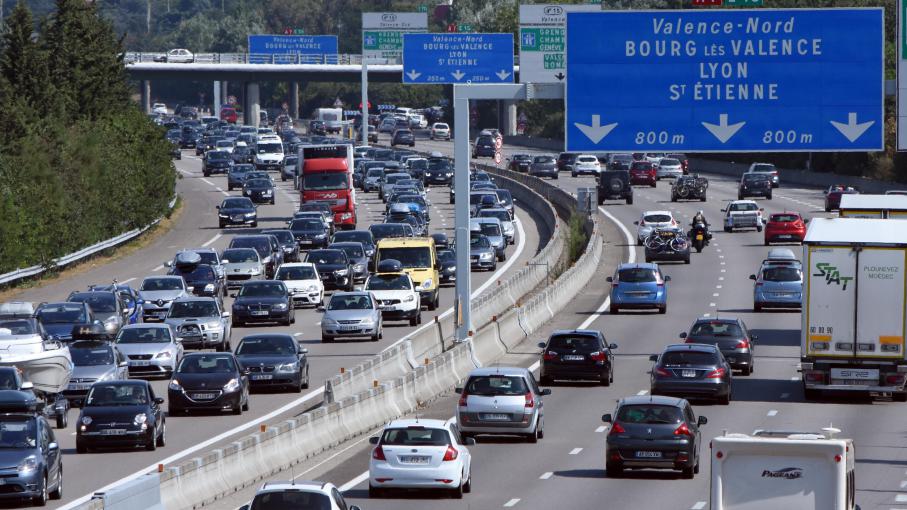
(0, 390, 63, 506)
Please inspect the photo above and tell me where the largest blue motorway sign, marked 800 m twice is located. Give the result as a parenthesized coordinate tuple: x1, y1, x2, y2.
(566, 8, 884, 152)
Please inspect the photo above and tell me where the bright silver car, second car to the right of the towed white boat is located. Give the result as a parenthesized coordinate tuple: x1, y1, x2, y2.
(116, 324, 183, 376)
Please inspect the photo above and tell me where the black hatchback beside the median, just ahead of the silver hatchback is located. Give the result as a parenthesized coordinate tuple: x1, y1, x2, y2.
(539, 329, 617, 386)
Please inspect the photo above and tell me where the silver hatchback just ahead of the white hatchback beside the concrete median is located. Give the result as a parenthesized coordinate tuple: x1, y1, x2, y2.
(456, 367, 551, 443)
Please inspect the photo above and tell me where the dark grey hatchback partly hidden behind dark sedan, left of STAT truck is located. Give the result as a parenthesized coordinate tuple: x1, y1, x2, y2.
(680, 317, 758, 375)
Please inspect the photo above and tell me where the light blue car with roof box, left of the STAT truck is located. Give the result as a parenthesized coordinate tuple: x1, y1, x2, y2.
(750, 249, 803, 312)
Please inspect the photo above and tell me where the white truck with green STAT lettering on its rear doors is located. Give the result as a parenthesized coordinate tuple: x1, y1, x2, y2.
(800, 218, 907, 402)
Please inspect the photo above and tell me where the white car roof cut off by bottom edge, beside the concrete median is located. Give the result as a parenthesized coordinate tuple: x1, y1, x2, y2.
(239, 481, 359, 510)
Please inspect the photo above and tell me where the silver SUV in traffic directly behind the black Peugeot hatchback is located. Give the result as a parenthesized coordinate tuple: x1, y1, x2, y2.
(165, 296, 232, 352)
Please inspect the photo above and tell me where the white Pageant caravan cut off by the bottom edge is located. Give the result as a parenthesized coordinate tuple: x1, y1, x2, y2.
(710, 428, 860, 510)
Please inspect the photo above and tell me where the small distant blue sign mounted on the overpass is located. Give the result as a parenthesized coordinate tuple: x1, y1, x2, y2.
(249, 35, 337, 64)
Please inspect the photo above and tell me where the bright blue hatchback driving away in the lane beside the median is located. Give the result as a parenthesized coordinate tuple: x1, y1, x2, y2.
(607, 263, 671, 314)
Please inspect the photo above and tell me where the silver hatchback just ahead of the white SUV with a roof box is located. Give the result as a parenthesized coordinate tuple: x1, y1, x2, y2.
(319, 292, 384, 343)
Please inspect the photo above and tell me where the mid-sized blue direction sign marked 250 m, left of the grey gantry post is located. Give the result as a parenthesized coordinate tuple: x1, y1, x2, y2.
(403, 33, 513, 83)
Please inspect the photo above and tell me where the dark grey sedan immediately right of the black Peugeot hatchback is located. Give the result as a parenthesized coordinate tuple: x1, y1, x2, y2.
(236, 334, 309, 392)
